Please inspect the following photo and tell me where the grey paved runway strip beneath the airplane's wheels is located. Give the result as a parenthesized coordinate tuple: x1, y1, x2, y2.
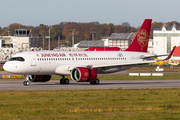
(0, 79, 180, 91)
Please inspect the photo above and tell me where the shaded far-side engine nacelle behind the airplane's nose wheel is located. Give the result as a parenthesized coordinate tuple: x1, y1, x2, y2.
(29, 75, 51, 82)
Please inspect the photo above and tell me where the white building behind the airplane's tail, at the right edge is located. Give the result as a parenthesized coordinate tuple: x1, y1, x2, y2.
(153, 25, 180, 55)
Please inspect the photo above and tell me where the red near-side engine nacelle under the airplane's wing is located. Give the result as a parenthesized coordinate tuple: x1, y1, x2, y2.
(71, 67, 97, 82)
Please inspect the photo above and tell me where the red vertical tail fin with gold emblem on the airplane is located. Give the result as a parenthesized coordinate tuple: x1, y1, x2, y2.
(125, 19, 152, 52)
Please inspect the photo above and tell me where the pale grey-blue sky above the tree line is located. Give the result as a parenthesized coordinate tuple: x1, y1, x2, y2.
(0, 0, 180, 27)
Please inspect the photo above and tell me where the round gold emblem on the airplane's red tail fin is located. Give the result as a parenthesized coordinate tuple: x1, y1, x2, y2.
(137, 29, 149, 50)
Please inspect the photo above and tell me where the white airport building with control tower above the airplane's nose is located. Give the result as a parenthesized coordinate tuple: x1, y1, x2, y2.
(0, 29, 42, 63)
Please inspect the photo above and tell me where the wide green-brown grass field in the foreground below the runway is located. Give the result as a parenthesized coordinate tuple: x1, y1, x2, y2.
(0, 88, 180, 120)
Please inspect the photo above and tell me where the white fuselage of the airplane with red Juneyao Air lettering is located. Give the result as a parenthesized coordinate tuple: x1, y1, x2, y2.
(4, 51, 154, 75)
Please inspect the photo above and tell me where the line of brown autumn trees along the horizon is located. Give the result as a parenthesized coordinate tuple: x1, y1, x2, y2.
(0, 21, 180, 49)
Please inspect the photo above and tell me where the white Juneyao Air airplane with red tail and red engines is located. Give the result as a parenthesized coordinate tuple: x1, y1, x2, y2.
(3, 19, 175, 86)
